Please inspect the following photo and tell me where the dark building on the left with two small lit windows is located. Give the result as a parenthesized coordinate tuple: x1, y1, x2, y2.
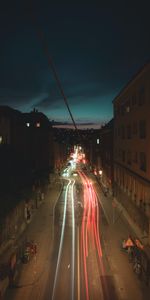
(21, 109, 54, 178)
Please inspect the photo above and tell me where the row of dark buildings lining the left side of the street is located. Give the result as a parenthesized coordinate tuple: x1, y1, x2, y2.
(0, 106, 68, 219)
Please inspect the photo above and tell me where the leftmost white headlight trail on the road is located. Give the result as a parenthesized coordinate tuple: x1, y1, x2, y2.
(52, 180, 71, 300)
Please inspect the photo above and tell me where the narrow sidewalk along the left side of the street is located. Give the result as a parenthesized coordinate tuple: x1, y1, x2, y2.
(0, 180, 62, 296)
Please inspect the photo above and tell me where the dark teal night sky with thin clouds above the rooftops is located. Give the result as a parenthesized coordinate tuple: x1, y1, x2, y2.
(0, 0, 150, 125)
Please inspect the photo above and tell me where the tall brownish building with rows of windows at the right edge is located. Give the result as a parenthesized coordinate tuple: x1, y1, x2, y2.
(113, 63, 150, 238)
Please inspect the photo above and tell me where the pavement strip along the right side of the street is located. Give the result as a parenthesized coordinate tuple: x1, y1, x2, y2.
(96, 183, 150, 300)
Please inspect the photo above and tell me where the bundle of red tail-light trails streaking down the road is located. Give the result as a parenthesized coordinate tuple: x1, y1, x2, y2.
(79, 172, 104, 300)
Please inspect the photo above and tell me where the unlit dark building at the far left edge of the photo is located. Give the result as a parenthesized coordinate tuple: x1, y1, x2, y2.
(0, 106, 31, 221)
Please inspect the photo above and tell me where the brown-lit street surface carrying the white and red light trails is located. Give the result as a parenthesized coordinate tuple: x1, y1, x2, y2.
(5, 171, 148, 300)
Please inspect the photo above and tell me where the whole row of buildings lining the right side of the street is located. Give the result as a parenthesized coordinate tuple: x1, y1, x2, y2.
(84, 63, 150, 242)
